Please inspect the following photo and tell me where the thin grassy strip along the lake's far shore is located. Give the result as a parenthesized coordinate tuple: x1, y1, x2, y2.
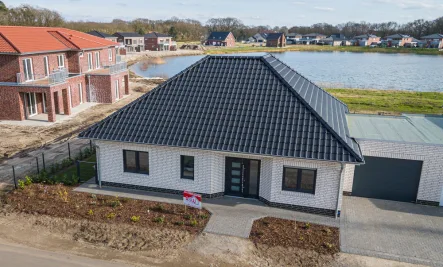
(205, 44, 443, 55)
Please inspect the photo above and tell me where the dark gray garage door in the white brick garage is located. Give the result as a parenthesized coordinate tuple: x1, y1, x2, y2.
(352, 156, 423, 202)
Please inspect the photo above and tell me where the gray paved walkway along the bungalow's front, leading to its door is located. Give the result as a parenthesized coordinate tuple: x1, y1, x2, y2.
(75, 184, 339, 238)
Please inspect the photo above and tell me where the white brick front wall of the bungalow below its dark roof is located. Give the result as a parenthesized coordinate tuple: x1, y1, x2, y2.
(96, 141, 352, 214)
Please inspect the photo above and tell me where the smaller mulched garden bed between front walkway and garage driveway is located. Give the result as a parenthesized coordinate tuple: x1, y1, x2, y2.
(250, 217, 340, 255)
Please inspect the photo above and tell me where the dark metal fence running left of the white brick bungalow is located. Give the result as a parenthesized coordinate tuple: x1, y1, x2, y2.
(0, 139, 96, 187)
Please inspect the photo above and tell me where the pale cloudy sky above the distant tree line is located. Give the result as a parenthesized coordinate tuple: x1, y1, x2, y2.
(3, 0, 443, 27)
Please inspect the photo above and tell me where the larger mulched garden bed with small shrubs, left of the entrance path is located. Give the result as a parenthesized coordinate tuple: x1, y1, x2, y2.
(5, 182, 210, 234)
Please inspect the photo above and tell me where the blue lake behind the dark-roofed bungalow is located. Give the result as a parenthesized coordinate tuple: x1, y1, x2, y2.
(130, 52, 443, 92)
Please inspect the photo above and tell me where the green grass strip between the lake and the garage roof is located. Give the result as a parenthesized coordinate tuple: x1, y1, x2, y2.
(327, 89, 443, 114)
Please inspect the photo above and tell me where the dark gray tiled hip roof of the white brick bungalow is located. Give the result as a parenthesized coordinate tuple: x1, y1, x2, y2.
(80, 55, 363, 162)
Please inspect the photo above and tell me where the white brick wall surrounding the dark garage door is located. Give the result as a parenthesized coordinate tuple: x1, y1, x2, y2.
(344, 140, 443, 202)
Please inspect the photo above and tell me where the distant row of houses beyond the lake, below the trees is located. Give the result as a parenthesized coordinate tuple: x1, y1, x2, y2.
(88, 31, 443, 54)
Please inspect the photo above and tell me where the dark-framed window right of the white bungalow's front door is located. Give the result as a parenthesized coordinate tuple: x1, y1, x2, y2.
(282, 167, 317, 194)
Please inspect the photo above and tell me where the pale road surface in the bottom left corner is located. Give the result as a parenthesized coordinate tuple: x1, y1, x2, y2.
(0, 242, 129, 267)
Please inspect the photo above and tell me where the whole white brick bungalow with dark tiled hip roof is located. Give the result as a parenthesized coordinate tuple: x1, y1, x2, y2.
(79, 55, 363, 216)
